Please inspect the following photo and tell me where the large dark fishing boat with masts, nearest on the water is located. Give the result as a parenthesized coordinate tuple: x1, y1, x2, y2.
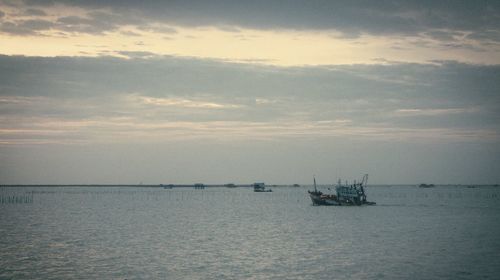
(308, 174, 375, 206)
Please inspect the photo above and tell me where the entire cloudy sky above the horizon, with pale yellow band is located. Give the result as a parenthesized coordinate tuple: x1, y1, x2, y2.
(0, 0, 500, 184)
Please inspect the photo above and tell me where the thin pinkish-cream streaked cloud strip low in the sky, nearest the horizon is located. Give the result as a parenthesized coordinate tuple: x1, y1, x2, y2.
(0, 116, 499, 145)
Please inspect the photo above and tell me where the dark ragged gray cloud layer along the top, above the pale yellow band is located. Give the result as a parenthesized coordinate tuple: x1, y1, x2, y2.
(0, 0, 500, 53)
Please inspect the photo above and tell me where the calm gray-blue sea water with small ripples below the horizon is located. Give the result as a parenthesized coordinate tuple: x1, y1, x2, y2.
(0, 186, 500, 279)
